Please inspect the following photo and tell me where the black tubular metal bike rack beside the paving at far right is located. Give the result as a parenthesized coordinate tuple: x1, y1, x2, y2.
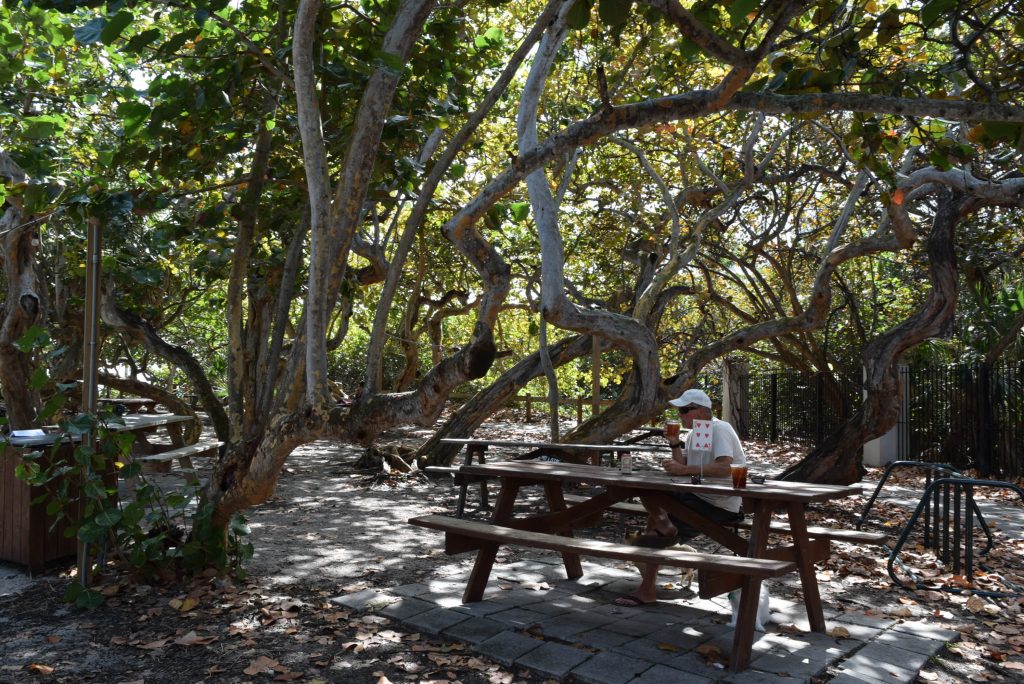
(884, 479, 1024, 597)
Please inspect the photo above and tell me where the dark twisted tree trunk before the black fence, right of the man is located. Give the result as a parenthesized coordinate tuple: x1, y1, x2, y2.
(781, 189, 964, 484)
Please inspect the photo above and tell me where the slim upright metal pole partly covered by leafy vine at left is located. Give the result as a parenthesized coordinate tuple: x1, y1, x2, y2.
(78, 217, 102, 587)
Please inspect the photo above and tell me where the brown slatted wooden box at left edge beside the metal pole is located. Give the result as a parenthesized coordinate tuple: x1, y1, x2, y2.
(0, 444, 117, 572)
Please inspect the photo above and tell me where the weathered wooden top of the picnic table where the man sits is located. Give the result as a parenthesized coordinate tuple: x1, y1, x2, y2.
(459, 461, 861, 504)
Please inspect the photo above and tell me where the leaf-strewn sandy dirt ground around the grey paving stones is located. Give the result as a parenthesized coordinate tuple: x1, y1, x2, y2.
(0, 422, 1020, 684)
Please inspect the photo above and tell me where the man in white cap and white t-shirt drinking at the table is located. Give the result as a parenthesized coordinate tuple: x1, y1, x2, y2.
(615, 389, 746, 606)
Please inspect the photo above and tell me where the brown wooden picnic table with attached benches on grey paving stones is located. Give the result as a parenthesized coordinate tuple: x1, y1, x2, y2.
(410, 461, 861, 672)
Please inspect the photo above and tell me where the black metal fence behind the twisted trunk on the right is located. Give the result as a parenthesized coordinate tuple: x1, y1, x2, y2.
(750, 361, 1024, 478)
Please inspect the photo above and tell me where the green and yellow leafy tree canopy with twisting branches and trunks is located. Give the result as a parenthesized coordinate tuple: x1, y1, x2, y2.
(0, 0, 1024, 557)
